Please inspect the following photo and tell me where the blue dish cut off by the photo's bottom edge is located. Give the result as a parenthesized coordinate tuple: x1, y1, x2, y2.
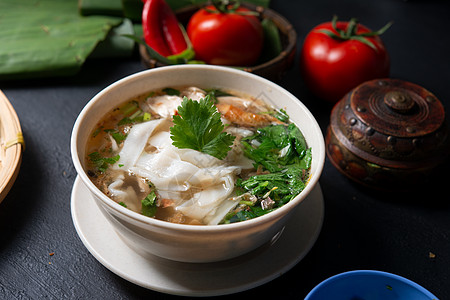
(305, 270, 438, 300)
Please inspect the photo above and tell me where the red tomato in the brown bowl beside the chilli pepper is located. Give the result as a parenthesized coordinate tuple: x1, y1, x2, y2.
(187, 5, 263, 66)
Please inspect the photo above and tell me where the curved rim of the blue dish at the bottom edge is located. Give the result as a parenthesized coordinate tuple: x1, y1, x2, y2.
(305, 270, 438, 300)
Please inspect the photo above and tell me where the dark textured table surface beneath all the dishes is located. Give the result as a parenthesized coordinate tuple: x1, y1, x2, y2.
(0, 0, 450, 300)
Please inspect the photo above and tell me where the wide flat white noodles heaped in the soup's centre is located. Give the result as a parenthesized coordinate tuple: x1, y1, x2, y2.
(109, 119, 241, 224)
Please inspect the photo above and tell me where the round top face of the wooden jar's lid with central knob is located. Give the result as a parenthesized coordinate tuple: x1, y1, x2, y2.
(350, 79, 445, 138)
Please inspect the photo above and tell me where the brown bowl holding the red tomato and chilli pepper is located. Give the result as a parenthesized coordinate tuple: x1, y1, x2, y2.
(139, 2, 297, 80)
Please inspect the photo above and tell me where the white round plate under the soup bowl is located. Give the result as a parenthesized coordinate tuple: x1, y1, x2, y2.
(71, 177, 324, 296)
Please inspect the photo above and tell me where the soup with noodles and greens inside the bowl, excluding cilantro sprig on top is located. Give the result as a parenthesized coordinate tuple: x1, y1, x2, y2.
(86, 87, 311, 225)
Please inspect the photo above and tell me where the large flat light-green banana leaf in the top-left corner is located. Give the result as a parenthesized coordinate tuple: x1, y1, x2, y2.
(0, 0, 122, 80)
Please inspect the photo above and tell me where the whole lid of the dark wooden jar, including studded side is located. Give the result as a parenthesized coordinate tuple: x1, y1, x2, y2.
(331, 79, 450, 168)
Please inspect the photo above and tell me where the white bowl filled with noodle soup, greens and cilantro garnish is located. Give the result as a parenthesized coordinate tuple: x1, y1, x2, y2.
(71, 65, 325, 262)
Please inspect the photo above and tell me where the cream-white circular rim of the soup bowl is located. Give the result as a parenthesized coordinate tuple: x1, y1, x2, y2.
(70, 65, 325, 233)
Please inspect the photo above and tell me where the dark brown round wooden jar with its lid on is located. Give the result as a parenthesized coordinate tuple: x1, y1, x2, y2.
(326, 79, 450, 190)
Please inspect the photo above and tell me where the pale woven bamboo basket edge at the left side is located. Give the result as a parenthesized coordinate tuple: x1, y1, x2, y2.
(0, 90, 24, 203)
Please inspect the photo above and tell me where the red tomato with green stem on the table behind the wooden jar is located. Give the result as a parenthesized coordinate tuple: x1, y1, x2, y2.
(300, 20, 390, 103)
